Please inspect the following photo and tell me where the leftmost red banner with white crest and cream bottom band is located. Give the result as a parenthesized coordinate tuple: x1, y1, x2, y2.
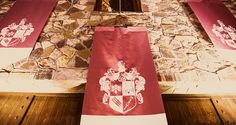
(0, 0, 57, 68)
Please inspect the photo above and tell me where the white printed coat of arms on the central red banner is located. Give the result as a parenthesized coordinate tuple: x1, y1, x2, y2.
(99, 61, 145, 114)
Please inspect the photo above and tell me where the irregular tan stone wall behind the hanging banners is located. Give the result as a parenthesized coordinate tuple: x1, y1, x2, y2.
(0, 0, 236, 84)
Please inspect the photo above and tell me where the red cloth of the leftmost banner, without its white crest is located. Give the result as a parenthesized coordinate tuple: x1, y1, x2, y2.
(0, 0, 57, 48)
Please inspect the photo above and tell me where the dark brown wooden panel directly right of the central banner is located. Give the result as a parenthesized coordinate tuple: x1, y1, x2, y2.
(164, 97, 221, 125)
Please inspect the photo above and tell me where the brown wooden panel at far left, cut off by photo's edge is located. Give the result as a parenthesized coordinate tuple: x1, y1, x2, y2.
(0, 94, 33, 125)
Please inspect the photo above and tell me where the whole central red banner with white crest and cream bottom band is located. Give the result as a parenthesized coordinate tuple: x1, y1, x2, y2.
(81, 27, 167, 125)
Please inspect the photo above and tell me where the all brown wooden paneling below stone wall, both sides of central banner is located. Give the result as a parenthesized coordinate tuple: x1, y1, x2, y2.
(0, 93, 236, 125)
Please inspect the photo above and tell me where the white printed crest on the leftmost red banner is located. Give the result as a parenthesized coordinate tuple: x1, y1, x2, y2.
(0, 18, 34, 47)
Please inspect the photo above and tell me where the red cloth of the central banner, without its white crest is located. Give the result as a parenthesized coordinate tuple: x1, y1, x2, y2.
(82, 27, 164, 115)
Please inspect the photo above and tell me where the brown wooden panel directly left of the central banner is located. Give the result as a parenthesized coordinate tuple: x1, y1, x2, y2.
(22, 94, 83, 125)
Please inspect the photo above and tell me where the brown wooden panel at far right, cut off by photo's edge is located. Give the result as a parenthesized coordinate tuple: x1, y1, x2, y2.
(212, 97, 236, 125)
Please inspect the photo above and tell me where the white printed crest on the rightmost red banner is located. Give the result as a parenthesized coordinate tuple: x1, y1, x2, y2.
(212, 20, 236, 48)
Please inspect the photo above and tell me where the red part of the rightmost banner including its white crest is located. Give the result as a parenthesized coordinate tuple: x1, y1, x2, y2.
(188, 0, 236, 50)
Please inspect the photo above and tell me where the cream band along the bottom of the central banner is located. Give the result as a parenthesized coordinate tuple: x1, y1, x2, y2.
(80, 113, 168, 125)
